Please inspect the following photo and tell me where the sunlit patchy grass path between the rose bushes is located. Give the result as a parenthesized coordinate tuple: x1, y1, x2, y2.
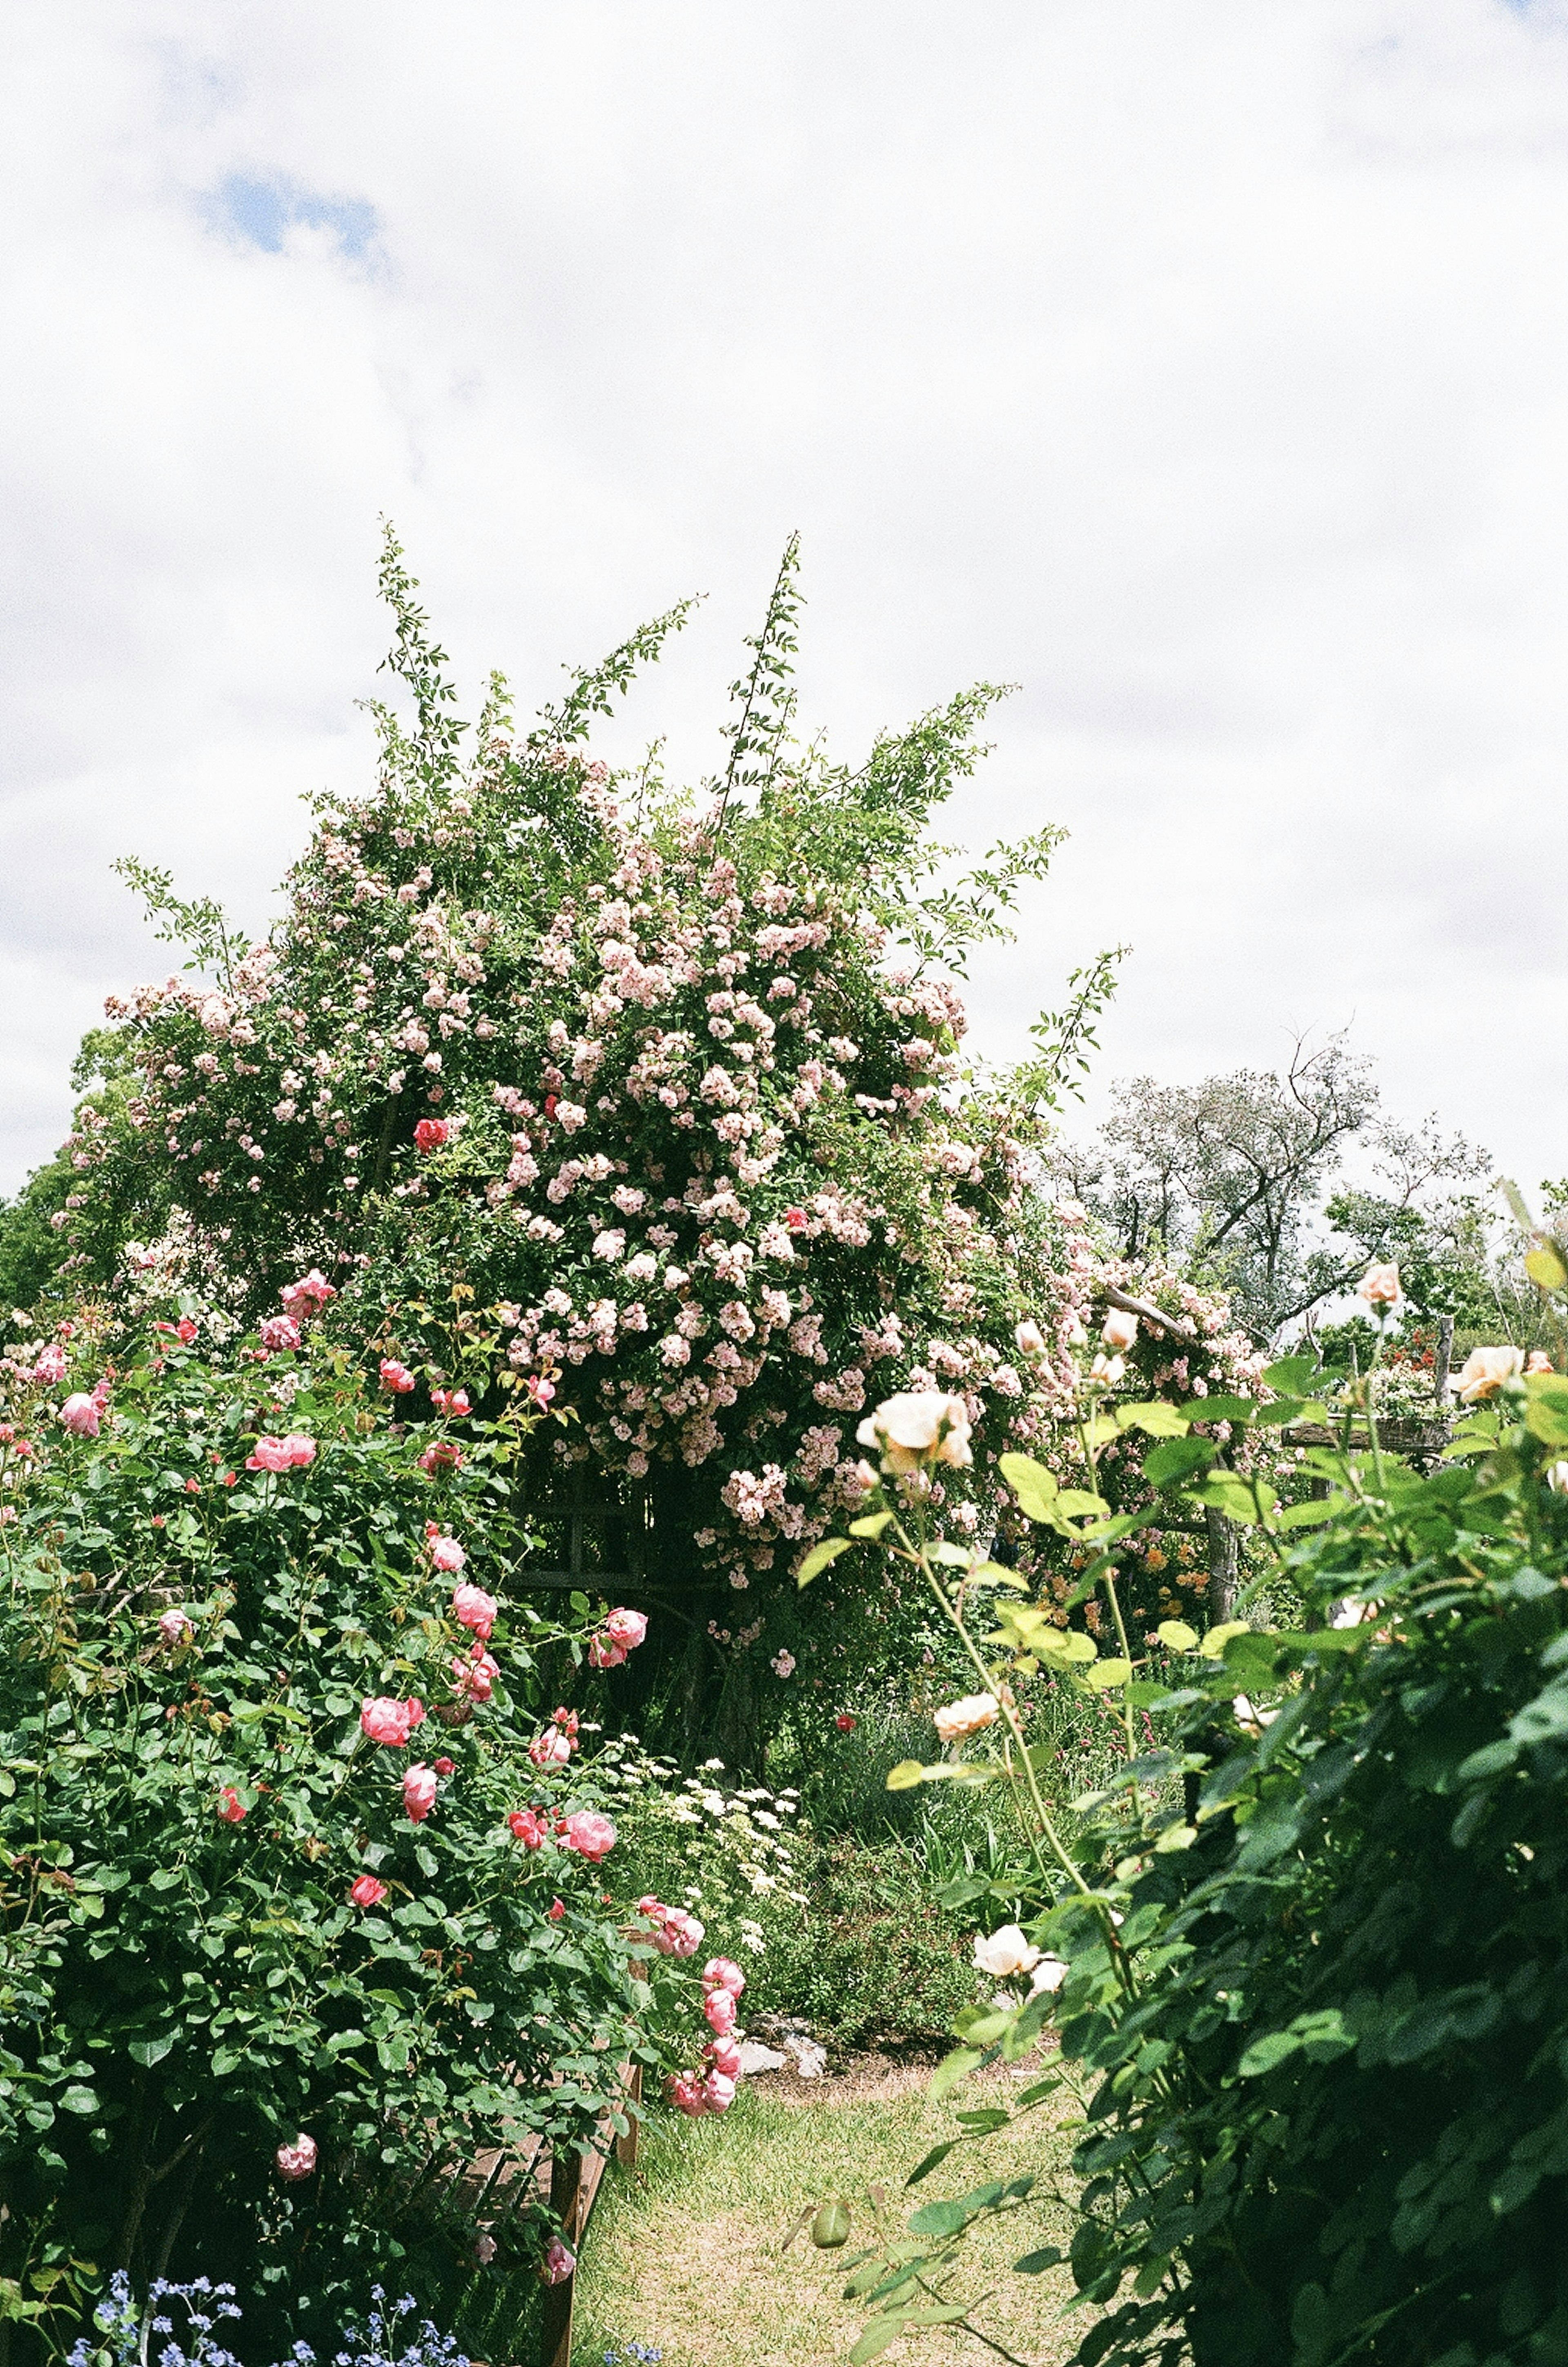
(572, 2064, 1083, 2367)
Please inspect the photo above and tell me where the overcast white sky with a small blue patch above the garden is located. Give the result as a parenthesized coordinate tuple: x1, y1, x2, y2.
(0, 0, 1568, 1188)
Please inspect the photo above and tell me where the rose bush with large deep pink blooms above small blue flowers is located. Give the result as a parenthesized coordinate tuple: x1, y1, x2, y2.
(0, 1276, 643, 2338)
